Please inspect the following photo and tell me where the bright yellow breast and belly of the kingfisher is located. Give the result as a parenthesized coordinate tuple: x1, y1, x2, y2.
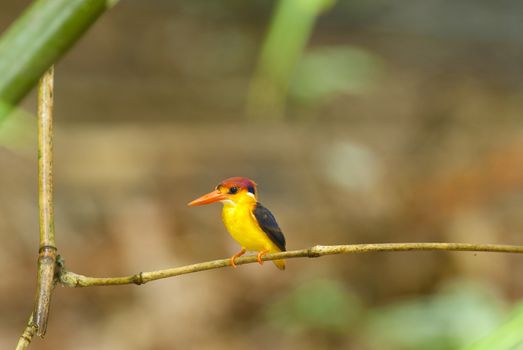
(222, 203, 280, 252)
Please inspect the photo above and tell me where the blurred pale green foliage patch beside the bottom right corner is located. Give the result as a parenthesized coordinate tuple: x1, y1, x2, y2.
(366, 281, 505, 350)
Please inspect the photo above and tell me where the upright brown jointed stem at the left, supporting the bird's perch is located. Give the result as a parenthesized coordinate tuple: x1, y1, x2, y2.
(34, 67, 56, 337)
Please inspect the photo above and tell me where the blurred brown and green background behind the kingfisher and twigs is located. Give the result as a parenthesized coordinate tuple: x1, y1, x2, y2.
(0, 0, 523, 350)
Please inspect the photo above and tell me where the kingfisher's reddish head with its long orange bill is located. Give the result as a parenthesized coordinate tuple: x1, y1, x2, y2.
(188, 177, 257, 206)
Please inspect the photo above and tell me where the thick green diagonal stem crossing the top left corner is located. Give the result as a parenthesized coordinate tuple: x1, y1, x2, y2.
(0, 0, 115, 122)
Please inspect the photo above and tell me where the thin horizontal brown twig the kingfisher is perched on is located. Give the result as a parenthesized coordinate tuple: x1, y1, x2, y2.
(59, 243, 523, 287)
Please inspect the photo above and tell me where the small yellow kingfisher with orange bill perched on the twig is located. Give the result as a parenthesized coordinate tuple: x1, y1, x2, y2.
(188, 177, 285, 270)
